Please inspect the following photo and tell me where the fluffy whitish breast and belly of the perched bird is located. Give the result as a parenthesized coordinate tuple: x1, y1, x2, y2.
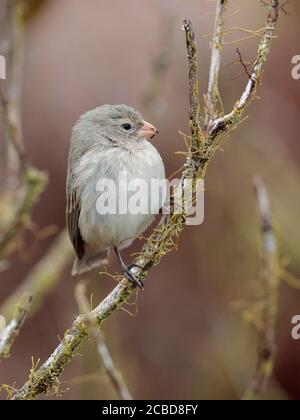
(79, 141, 165, 252)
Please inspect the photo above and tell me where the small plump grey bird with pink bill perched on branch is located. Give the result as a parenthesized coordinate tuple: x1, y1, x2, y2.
(66, 105, 165, 288)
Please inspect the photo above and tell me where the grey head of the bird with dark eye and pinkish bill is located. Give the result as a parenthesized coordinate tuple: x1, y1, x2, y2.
(75, 105, 158, 148)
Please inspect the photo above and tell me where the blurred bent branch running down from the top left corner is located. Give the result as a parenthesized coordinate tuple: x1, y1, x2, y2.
(0, 0, 47, 258)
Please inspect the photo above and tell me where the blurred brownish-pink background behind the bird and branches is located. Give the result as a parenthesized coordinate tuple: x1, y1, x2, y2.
(0, 0, 300, 399)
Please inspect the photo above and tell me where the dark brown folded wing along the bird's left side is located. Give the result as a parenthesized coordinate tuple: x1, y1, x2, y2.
(67, 174, 84, 259)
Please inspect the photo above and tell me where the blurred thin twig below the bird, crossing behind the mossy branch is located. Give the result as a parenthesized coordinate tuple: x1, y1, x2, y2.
(76, 283, 133, 400)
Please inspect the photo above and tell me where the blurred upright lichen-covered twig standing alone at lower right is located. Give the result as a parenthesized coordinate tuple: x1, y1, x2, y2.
(244, 178, 281, 400)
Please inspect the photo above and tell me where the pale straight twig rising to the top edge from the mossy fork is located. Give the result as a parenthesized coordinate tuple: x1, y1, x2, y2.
(205, 0, 228, 129)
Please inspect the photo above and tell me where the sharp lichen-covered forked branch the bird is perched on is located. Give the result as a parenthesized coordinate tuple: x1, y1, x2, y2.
(12, 0, 279, 400)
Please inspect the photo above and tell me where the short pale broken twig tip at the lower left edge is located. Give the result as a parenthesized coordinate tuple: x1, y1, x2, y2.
(0, 295, 31, 359)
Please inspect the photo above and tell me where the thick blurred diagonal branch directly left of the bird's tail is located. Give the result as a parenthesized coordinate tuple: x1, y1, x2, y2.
(0, 229, 74, 319)
